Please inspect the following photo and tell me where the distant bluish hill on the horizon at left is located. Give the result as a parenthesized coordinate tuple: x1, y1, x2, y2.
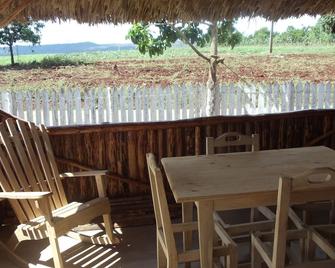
(0, 42, 135, 56)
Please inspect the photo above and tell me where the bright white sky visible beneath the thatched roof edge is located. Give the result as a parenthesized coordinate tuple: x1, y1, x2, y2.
(37, 16, 318, 45)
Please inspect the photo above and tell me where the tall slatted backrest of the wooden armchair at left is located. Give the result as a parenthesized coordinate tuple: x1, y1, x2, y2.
(0, 118, 67, 223)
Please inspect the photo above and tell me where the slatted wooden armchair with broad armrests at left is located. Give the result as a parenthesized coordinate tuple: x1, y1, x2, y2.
(0, 119, 117, 268)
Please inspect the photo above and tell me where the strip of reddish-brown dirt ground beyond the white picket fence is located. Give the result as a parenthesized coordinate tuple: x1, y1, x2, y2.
(0, 54, 335, 89)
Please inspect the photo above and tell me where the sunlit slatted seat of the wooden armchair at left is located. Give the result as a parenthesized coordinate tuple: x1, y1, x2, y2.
(17, 197, 110, 240)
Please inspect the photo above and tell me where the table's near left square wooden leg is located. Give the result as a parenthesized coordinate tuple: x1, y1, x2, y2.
(196, 200, 214, 268)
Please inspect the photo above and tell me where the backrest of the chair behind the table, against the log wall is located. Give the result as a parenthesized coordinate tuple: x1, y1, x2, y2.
(206, 132, 259, 155)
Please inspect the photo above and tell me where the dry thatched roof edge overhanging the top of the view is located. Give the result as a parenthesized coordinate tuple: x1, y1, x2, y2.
(0, 0, 335, 24)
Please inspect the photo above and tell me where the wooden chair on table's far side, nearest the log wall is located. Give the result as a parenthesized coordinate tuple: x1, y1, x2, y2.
(206, 132, 275, 239)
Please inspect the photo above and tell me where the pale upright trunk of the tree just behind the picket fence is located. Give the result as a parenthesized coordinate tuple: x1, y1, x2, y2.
(206, 21, 219, 116)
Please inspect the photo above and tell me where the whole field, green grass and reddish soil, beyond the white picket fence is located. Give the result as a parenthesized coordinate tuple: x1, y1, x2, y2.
(0, 46, 335, 89)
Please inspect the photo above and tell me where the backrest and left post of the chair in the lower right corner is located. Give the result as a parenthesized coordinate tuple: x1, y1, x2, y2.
(272, 167, 335, 267)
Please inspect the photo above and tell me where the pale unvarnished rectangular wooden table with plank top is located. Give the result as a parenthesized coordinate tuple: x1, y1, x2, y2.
(162, 147, 335, 268)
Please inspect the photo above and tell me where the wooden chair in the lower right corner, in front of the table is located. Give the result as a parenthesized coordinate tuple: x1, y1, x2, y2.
(252, 168, 335, 268)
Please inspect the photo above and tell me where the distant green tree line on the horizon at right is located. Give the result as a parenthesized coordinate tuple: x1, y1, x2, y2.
(241, 15, 335, 45)
